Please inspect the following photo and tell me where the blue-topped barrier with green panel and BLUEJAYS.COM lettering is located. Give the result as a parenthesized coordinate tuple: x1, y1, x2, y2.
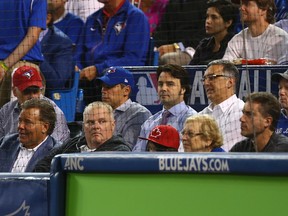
(50, 153, 288, 216)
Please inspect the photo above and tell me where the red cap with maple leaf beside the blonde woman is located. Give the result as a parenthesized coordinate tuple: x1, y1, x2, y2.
(139, 125, 180, 149)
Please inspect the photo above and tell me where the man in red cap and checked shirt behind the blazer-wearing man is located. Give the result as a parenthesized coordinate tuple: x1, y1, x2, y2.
(0, 66, 70, 142)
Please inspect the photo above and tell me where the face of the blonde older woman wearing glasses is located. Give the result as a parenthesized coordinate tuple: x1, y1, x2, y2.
(181, 121, 212, 152)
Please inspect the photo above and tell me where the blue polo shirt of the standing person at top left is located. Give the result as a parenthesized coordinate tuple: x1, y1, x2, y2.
(0, 0, 47, 61)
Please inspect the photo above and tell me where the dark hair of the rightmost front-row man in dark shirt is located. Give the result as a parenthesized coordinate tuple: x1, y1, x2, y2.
(245, 92, 281, 131)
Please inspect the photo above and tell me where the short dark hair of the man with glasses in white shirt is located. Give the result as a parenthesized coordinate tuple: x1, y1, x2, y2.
(206, 59, 239, 92)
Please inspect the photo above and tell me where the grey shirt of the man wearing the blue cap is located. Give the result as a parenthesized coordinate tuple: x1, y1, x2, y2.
(114, 99, 152, 148)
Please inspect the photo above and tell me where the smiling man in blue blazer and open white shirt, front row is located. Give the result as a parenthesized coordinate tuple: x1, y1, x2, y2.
(0, 98, 58, 172)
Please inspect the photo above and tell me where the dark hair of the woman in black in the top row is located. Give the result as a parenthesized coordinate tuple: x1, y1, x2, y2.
(207, 0, 239, 32)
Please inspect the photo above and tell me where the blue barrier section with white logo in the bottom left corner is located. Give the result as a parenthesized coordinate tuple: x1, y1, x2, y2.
(0, 173, 50, 216)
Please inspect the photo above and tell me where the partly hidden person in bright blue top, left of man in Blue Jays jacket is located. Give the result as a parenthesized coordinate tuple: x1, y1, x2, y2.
(48, 0, 84, 46)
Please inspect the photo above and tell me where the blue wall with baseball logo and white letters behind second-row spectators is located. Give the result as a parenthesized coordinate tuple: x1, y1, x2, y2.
(126, 65, 288, 114)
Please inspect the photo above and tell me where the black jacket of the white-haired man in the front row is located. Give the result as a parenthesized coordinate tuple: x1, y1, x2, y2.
(34, 135, 131, 172)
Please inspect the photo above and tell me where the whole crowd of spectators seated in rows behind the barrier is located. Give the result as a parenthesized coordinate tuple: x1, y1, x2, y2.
(0, 0, 288, 172)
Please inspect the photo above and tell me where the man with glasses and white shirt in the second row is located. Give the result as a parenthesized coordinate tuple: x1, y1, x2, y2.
(200, 60, 244, 151)
